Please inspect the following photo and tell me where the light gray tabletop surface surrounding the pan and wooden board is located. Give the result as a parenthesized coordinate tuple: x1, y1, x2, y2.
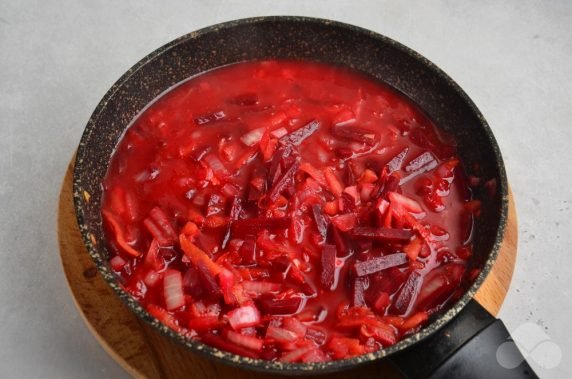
(0, 0, 572, 378)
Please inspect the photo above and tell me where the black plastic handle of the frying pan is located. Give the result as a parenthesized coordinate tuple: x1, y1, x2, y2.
(390, 300, 538, 379)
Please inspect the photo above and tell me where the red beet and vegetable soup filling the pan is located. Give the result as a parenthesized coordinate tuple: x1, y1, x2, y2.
(102, 61, 478, 362)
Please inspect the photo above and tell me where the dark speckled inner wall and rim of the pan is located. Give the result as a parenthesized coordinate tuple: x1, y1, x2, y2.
(73, 17, 508, 375)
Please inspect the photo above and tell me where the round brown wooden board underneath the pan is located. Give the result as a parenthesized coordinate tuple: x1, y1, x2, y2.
(58, 164, 517, 379)
